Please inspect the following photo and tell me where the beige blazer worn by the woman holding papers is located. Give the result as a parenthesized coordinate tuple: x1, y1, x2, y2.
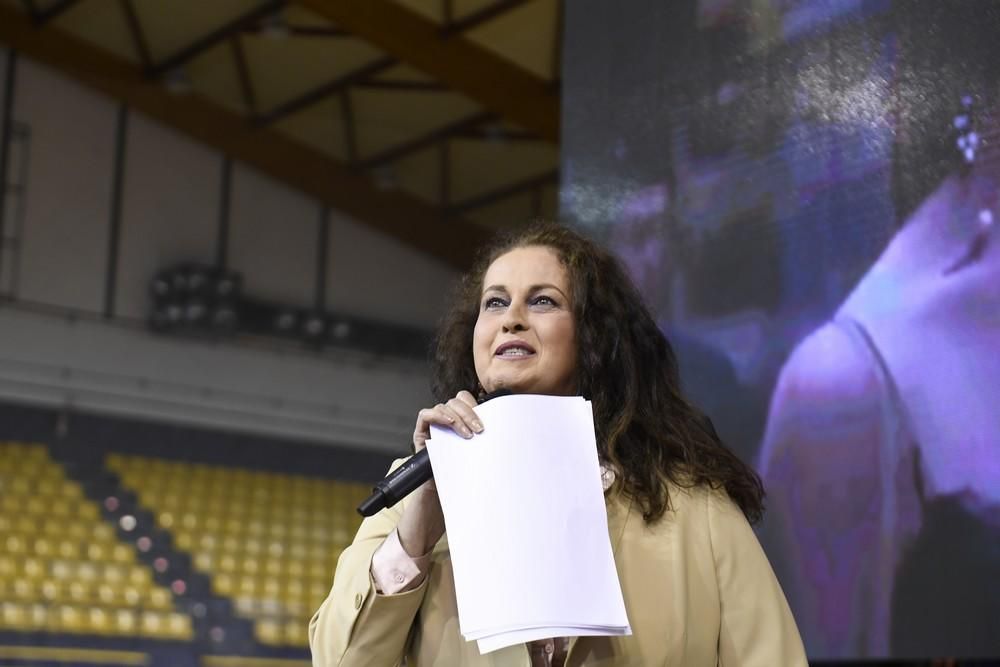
(309, 462, 807, 667)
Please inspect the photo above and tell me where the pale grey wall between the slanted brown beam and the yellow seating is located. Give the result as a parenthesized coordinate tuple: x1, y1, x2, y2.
(0, 52, 457, 449)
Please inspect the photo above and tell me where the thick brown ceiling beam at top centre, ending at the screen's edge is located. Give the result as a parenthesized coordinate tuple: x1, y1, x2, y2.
(293, 0, 559, 143)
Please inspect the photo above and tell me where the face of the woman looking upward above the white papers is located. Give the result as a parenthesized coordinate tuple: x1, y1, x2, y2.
(472, 246, 577, 396)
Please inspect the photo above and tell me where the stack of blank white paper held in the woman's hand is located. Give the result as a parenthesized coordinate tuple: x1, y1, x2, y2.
(427, 395, 632, 653)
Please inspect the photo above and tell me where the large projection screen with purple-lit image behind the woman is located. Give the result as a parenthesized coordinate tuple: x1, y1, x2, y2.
(561, 0, 1000, 658)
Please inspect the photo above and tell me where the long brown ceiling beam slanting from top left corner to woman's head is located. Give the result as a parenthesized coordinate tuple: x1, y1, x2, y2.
(0, 5, 488, 269)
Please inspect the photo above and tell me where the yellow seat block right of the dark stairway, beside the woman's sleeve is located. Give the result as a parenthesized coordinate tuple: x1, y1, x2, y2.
(107, 454, 370, 647)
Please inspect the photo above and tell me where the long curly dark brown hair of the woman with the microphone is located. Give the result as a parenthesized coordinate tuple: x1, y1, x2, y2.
(432, 222, 764, 523)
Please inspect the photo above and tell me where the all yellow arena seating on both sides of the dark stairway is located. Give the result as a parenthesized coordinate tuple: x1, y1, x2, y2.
(0, 441, 370, 665)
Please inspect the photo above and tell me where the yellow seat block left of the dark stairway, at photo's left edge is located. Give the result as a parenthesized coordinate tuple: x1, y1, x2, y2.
(0, 442, 192, 640)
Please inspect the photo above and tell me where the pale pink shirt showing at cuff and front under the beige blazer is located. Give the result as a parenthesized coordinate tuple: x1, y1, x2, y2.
(371, 465, 615, 667)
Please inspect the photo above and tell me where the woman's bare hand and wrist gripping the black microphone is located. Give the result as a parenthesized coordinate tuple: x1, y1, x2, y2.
(396, 391, 483, 558)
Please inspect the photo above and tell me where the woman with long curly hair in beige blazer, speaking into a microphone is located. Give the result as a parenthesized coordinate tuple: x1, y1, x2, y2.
(309, 224, 806, 667)
